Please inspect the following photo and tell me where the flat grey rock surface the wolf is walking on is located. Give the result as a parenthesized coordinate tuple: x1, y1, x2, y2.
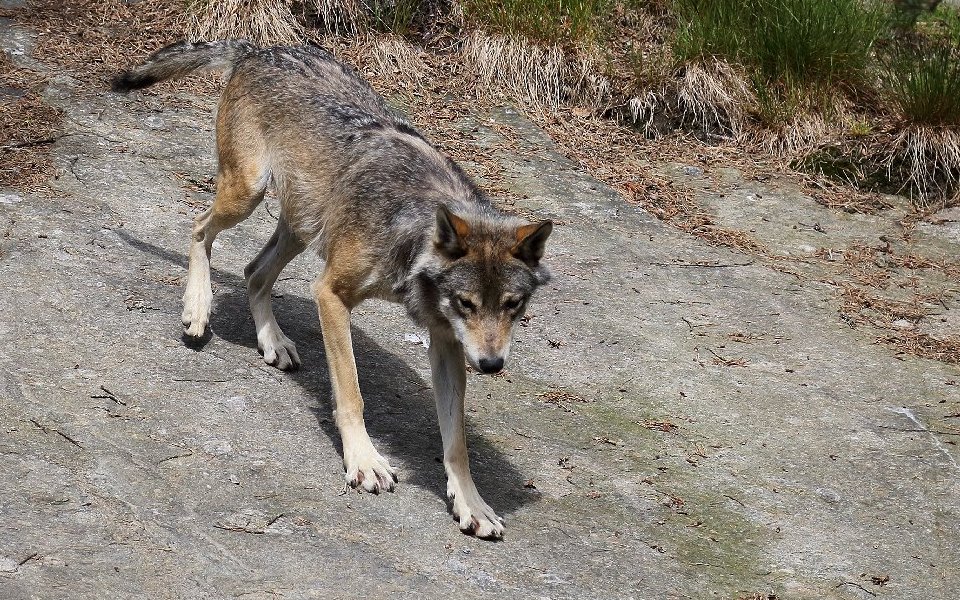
(0, 18, 960, 600)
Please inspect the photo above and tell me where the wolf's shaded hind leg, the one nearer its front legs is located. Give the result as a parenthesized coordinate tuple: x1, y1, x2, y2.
(243, 215, 306, 370)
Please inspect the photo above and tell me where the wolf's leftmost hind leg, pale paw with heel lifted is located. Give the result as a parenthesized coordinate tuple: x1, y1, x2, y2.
(181, 156, 269, 337)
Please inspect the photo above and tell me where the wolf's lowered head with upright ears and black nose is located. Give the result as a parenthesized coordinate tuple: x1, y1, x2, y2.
(408, 206, 553, 373)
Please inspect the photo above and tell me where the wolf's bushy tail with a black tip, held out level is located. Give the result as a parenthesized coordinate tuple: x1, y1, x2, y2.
(110, 40, 256, 92)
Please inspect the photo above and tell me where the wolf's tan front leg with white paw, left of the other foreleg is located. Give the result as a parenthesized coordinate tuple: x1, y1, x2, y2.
(313, 276, 397, 494)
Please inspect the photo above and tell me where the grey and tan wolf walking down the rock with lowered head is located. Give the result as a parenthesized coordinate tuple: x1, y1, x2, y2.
(111, 40, 553, 538)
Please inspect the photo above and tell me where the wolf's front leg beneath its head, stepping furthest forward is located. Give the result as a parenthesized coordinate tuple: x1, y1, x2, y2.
(430, 330, 503, 538)
